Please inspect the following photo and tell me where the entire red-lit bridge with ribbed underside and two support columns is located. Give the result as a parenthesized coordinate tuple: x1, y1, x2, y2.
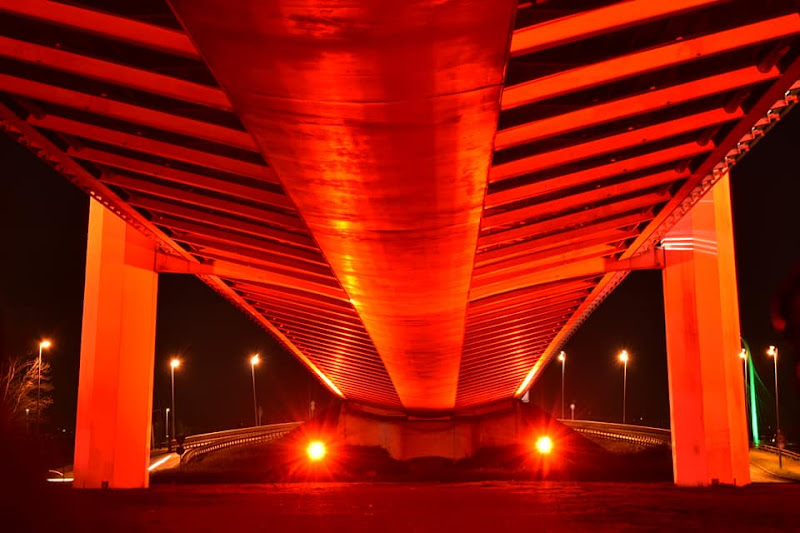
(0, 0, 800, 486)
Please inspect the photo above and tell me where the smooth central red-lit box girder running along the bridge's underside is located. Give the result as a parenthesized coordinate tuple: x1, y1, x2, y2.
(171, 0, 513, 414)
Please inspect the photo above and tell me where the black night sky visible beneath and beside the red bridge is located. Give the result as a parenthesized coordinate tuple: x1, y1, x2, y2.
(0, 111, 800, 440)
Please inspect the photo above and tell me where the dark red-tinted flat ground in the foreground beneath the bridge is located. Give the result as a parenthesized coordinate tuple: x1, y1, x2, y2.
(10, 481, 800, 533)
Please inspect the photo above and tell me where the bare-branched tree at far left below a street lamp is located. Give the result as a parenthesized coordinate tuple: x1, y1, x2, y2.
(0, 355, 53, 422)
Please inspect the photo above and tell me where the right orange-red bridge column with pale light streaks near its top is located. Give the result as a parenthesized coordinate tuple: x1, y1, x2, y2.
(663, 175, 750, 486)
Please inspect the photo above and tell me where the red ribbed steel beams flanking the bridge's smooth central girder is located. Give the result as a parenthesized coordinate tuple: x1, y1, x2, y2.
(0, 0, 800, 410)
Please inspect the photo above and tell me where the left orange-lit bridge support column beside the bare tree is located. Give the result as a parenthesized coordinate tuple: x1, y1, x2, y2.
(73, 200, 158, 488)
